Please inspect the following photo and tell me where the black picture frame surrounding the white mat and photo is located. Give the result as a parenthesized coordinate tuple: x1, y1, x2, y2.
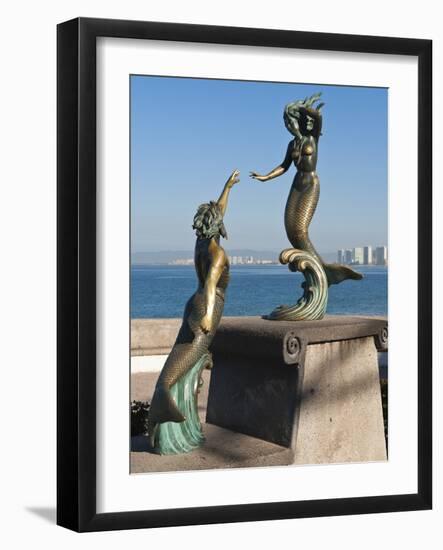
(57, 18, 432, 532)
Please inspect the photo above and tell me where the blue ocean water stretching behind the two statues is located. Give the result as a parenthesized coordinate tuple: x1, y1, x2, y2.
(131, 265, 388, 319)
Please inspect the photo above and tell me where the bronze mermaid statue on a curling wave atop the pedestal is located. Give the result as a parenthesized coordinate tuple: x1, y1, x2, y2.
(250, 93, 362, 320)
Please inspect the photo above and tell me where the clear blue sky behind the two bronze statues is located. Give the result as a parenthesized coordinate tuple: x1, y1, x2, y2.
(131, 76, 388, 252)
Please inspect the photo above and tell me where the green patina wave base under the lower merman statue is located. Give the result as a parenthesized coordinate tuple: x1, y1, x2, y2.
(150, 353, 212, 455)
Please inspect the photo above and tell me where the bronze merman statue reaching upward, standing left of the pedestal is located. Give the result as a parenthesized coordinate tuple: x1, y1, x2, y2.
(148, 170, 239, 454)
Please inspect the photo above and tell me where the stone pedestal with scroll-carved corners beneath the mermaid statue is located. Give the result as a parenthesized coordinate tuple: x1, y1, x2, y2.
(206, 316, 387, 464)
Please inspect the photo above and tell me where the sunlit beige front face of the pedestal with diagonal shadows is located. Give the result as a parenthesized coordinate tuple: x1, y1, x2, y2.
(294, 337, 386, 464)
